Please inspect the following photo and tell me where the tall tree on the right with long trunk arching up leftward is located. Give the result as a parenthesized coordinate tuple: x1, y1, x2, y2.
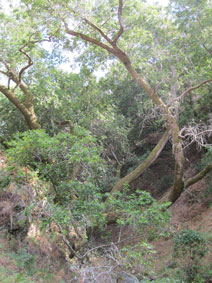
(19, 0, 212, 202)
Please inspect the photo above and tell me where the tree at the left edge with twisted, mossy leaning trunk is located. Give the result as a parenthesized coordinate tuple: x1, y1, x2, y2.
(0, 11, 41, 129)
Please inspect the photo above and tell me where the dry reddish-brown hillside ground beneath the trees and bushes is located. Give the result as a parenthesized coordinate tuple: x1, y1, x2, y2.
(0, 150, 212, 283)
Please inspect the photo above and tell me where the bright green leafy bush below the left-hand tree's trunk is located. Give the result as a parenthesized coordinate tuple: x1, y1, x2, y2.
(7, 127, 105, 203)
